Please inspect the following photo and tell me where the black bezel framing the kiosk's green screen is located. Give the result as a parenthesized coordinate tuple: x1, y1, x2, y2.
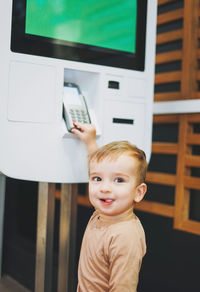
(11, 0, 147, 71)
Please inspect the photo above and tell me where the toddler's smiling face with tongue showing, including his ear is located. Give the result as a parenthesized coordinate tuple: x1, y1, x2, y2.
(89, 154, 146, 216)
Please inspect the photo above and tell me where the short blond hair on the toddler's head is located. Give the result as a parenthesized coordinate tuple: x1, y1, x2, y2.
(89, 141, 147, 184)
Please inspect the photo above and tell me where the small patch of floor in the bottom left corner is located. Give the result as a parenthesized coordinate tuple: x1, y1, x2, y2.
(0, 276, 31, 292)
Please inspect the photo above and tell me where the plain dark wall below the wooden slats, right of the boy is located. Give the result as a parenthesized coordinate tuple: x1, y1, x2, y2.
(137, 212, 200, 292)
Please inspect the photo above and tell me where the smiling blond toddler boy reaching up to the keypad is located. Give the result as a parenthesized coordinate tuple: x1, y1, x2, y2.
(73, 124, 147, 292)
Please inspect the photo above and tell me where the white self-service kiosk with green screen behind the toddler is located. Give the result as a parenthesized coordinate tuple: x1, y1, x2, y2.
(0, 0, 157, 183)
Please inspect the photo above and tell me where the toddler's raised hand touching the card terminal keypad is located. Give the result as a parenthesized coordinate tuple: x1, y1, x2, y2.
(71, 123, 98, 154)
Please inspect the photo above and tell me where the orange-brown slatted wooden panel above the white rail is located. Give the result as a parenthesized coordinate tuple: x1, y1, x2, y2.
(155, 0, 200, 101)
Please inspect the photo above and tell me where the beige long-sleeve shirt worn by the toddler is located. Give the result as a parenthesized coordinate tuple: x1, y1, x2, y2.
(77, 209, 146, 292)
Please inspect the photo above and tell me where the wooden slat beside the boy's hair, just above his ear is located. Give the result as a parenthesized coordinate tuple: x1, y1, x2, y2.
(146, 171, 176, 186)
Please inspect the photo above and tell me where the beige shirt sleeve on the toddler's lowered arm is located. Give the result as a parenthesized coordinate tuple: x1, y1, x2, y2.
(108, 230, 144, 292)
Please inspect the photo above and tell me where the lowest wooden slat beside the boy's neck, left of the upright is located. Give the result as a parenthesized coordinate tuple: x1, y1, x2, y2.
(135, 200, 174, 217)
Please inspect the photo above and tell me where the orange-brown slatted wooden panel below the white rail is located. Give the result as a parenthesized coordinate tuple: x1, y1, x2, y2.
(136, 114, 200, 235)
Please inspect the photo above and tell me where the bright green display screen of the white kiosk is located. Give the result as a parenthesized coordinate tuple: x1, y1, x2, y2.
(25, 0, 137, 53)
